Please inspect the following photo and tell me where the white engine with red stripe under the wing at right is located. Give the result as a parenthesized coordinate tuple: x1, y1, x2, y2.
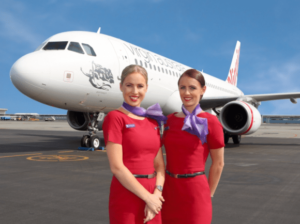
(220, 101, 261, 135)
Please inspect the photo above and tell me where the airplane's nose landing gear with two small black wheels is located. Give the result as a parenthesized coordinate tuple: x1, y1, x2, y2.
(81, 113, 105, 149)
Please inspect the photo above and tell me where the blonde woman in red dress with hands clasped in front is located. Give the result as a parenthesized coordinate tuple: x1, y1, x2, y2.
(103, 65, 165, 224)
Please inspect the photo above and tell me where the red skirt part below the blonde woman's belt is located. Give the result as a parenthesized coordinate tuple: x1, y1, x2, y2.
(109, 177, 162, 224)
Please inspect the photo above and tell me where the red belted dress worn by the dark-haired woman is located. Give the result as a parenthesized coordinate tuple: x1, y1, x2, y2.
(162, 112, 224, 224)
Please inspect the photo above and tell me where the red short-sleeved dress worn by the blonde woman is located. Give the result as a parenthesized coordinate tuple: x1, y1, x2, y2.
(103, 110, 161, 224)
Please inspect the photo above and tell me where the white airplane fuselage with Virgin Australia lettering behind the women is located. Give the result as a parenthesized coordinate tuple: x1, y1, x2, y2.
(10, 31, 244, 114)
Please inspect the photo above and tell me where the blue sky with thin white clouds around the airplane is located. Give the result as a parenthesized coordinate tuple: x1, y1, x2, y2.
(0, 0, 300, 115)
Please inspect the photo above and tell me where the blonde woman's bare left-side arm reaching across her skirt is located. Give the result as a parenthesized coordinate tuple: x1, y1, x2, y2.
(106, 141, 164, 214)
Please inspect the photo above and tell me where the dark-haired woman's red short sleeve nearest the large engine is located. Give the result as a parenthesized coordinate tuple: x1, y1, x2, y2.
(207, 115, 225, 149)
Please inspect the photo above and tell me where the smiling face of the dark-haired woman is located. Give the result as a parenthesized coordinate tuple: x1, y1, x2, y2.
(179, 75, 206, 109)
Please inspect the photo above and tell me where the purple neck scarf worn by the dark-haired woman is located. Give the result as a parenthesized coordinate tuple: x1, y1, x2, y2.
(181, 104, 208, 144)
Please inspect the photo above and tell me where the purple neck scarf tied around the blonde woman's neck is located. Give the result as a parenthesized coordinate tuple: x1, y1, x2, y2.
(122, 102, 168, 127)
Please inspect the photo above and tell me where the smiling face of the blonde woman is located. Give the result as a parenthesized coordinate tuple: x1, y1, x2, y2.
(120, 72, 148, 107)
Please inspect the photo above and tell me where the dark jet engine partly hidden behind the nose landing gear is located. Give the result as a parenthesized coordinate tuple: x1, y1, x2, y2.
(67, 111, 89, 131)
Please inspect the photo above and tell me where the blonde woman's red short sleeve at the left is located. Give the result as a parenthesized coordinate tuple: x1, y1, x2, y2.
(102, 111, 124, 145)
